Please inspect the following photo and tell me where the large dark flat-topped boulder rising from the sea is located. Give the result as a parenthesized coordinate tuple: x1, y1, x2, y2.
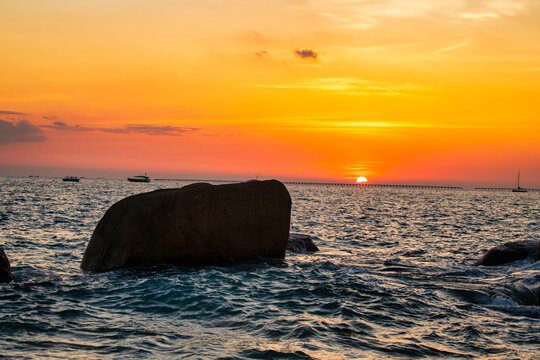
(81, 180, 291, 271)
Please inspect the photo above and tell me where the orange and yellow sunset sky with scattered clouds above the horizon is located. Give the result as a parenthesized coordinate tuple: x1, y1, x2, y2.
(0, 0, 540, 187)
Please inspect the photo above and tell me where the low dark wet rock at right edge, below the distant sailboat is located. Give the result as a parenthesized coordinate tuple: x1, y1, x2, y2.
(473, 240, 538, 266)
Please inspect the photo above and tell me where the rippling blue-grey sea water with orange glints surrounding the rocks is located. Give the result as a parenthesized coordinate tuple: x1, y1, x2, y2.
(0, 178, 540, 359)
